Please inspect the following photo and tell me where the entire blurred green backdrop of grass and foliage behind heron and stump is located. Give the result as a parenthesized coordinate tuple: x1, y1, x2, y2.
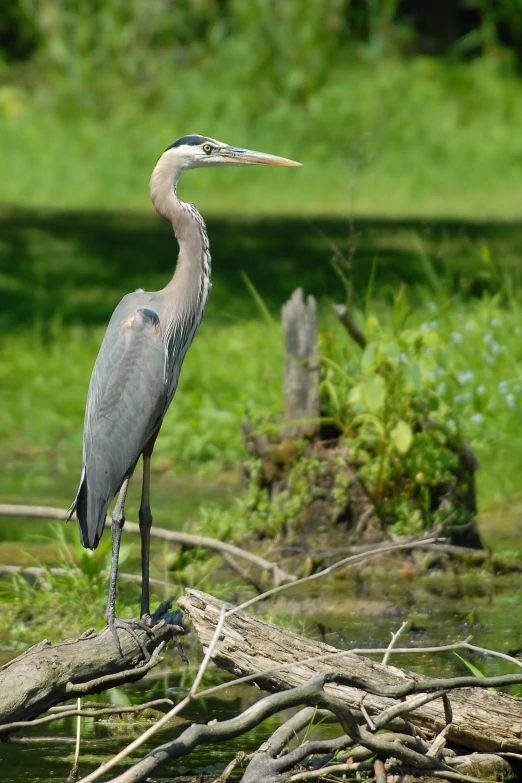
(0, 0, 522, 557)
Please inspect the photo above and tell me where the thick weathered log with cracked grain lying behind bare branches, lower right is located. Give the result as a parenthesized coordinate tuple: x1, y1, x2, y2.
(178, 590, 522, 753)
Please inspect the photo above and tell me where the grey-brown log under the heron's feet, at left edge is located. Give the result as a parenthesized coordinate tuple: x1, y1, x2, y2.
(0, 602, 183, 737)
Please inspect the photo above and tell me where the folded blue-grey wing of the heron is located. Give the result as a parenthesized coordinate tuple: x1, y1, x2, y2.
(75, 308, 167, 549)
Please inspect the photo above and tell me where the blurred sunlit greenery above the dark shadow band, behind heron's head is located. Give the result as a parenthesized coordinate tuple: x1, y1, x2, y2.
(0, 0, 522, 218)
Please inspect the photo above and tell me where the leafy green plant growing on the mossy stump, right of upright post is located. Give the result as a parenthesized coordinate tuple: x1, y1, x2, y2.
(321, 295, 467, 533)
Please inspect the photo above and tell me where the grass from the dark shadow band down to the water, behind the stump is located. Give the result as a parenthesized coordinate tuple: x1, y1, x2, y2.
(4, 213, 522, 520)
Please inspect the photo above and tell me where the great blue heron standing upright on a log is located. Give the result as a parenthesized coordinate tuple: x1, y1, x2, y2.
(70, 135, 301, 649)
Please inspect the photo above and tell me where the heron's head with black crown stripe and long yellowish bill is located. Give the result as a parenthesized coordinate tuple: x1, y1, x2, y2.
(163, 134, 301, 170)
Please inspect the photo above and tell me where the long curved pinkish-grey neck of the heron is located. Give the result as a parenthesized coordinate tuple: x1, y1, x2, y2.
(150, 156, 211, 326)
